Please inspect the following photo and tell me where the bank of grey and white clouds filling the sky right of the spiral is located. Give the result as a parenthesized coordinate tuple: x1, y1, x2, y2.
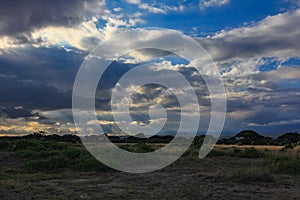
(197, 9, 300, 131)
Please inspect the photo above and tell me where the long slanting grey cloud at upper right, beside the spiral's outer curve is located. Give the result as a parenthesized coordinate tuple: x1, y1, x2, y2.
(199, 9, 300, 61)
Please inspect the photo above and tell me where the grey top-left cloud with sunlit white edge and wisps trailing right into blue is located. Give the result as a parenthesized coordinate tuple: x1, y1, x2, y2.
(0, 0, 144, 51)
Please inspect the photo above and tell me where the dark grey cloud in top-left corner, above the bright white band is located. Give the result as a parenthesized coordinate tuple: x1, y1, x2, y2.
(0, 0, 98, 36)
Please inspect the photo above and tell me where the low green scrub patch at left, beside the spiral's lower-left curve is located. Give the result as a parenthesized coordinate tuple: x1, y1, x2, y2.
(0, 139, 109, 172)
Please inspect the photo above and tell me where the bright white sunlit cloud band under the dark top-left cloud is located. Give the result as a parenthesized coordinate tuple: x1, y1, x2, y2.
(0, 14, 144, 53)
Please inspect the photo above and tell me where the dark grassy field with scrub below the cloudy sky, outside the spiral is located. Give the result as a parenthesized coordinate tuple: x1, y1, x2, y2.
(0, 139, 300, 200)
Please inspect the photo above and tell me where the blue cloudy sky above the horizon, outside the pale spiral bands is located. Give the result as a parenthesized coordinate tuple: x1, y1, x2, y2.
(0, 0, 300, 135)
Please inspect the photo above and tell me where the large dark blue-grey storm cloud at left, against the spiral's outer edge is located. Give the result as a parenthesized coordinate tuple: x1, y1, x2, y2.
(0, 48, 83, 110)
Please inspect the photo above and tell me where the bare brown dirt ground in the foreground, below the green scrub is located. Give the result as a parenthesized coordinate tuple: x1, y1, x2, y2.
(0, 152, 300, 200)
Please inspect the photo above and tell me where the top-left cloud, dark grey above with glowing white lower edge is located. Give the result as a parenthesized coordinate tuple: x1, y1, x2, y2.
(0, 0, 105, 53)
